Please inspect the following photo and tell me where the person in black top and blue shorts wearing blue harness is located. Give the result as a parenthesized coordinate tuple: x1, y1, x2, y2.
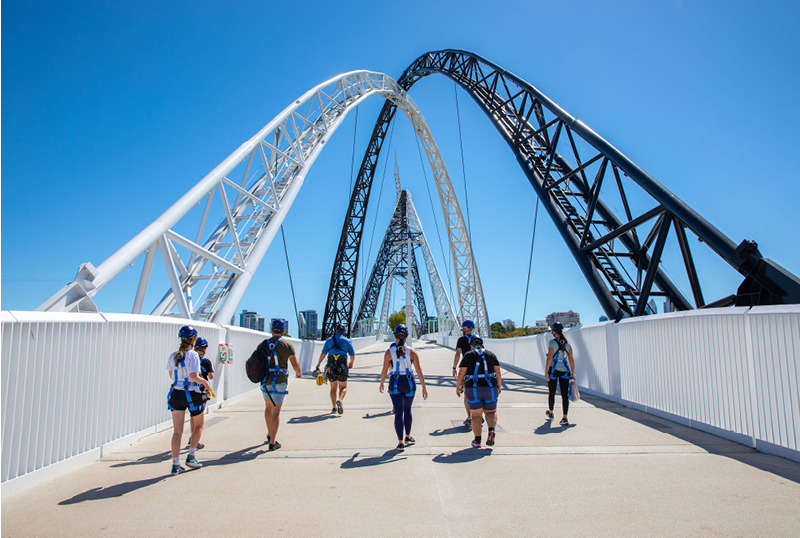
(456, 335, 503, 448)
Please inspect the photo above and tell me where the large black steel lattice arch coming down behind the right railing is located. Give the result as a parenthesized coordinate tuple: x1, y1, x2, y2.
(326, 50, 800, 336)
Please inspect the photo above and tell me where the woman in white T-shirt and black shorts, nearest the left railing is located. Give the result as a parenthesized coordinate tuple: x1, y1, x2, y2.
(167, 325, 211, 475)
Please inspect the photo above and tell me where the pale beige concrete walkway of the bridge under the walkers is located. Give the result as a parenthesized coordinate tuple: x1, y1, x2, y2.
(2, 343, 800, 538)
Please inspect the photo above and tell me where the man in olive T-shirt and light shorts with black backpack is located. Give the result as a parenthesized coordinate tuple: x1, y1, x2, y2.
(256, 319, 303, 450)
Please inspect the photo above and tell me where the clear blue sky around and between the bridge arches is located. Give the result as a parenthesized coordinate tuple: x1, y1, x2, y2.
(1, 0, 800, 327)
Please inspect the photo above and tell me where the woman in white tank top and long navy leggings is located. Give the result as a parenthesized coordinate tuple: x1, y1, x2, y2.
(380, 324, 428, 452)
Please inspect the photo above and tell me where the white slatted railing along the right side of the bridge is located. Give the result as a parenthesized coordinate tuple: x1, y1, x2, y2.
(438, 305, 800, 461)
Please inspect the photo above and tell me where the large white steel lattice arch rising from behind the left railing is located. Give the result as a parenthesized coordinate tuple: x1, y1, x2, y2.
(37, 71, 489, 334)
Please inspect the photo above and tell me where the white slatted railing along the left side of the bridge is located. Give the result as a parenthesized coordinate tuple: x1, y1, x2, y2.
(0, 312, 375, 494)
